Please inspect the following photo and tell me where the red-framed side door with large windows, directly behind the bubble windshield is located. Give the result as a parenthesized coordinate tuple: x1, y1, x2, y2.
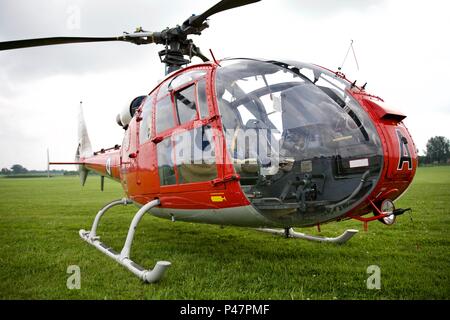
(152, 70, 224, 193)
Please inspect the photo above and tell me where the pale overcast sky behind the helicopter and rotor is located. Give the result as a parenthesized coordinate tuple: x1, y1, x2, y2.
(0, 0, 450, 169)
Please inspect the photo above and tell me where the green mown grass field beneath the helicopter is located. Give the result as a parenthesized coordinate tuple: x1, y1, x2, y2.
(0, 167, 450, 299)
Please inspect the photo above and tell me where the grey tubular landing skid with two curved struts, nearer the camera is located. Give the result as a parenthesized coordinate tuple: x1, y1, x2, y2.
(79, 198, 171, 283)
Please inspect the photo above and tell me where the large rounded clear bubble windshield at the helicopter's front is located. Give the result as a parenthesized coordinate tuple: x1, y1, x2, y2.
(216, 59, 382, 226)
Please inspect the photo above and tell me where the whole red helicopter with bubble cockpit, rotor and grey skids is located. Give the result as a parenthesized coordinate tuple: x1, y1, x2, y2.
(0, 0, 418, 283)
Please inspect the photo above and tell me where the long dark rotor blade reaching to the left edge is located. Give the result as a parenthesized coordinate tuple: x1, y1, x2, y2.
(0, 32, 156, 51)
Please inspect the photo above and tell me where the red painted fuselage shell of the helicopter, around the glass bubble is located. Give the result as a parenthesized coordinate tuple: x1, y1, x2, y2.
(80, 58, 417, 227)
